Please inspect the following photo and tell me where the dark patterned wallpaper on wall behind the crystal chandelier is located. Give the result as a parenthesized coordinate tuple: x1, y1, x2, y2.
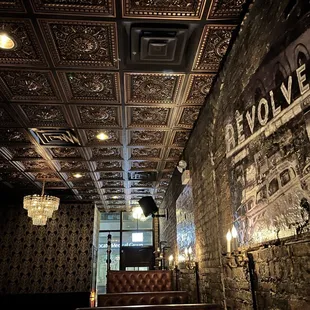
(0, 204, 96, 294)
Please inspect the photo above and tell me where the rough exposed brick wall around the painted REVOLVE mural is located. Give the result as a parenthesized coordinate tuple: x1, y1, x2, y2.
(160, 0, 310, 310)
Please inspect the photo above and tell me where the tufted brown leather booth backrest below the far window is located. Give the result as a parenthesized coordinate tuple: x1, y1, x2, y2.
(107, 270, 172, 293)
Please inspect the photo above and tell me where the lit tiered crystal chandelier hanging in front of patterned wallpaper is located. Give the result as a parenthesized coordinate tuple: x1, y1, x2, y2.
(24, 181, 60, 225)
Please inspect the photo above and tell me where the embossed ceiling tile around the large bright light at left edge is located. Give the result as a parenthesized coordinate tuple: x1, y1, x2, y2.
(0, 18, 46, 66)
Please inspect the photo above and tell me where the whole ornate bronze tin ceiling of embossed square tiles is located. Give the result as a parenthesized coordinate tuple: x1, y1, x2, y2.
(0, 0, 245, 210)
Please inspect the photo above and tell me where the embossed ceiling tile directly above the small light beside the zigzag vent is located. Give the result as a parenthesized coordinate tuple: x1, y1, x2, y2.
(77, 105, 121, 127)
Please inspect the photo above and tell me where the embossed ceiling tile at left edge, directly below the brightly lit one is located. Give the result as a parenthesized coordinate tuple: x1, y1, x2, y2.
(0, 69, 59, 102)
